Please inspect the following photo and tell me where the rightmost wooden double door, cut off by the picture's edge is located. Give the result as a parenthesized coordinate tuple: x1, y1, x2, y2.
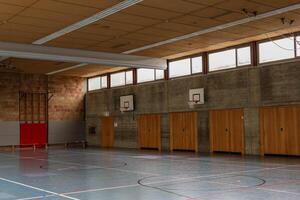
(260, 105, 300, 155)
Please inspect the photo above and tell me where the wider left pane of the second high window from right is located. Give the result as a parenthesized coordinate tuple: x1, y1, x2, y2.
(208, 49, 236, 71)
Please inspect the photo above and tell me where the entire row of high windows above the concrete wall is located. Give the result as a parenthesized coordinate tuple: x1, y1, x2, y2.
(88, 35, 300, 91)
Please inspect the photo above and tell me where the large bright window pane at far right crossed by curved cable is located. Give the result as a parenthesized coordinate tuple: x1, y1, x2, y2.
(258, 37, 295, 63)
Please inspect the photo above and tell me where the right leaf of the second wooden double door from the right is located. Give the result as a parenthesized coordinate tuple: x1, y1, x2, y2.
(228, 109, 245, 154)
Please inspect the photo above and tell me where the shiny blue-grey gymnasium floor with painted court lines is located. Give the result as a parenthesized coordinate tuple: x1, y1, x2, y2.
(0, 149, 300, 200)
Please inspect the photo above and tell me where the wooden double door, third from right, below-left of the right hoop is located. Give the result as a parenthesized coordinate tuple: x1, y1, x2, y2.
(169, 112, 198, 152)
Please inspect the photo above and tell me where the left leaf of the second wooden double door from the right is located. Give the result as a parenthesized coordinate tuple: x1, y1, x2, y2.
(209, 110, 230, 152)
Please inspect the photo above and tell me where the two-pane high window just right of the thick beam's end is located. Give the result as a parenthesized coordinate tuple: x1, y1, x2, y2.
(169, 56, 203, 78)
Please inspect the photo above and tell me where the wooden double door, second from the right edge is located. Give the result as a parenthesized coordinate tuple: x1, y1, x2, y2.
(209, 109, 245, 154)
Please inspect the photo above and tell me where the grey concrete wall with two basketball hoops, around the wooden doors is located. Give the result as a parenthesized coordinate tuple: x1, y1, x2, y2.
(86, 61, 300, 154)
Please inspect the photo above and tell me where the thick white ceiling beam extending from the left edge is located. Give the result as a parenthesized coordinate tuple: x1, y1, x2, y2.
(0, 42, 167, 69)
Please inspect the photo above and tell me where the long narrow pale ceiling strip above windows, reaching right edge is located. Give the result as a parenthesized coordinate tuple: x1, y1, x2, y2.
(124, 3, 300, 54)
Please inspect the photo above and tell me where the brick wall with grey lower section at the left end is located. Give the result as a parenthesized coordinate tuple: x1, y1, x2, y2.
(0, 73, 86, 146)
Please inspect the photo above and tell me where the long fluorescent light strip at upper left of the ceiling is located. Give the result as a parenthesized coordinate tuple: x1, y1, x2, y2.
(32, 0, 143, 44)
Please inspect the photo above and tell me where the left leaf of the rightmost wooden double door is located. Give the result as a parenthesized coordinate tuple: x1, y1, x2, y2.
(260, 107, 287, 154)
